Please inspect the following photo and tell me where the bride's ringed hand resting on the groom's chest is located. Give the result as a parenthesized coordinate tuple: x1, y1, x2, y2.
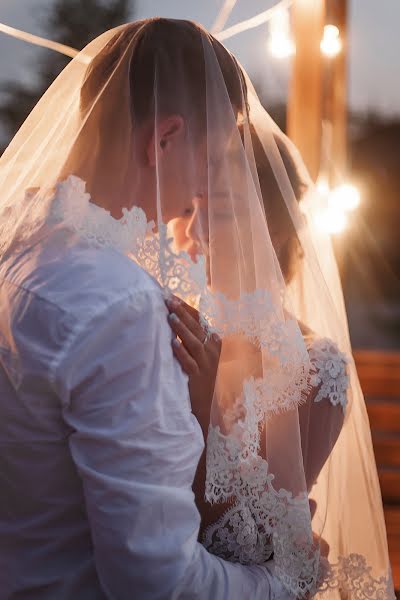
(166, 296, 222, 437)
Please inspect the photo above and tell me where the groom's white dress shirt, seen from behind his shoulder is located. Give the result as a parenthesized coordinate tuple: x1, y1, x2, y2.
(0, 228, 294, 600)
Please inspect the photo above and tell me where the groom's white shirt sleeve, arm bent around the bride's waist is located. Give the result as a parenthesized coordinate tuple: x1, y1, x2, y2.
(56, 291, 288, 600)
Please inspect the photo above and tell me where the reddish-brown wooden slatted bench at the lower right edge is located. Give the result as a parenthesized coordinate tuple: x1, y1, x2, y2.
(354, 350, 400, 590)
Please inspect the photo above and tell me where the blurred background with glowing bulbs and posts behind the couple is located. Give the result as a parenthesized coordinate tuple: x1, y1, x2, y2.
(0, 0, 400, 588)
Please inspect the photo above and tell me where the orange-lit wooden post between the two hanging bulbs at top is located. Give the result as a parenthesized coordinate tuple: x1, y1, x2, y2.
(287, 0, 325, 180)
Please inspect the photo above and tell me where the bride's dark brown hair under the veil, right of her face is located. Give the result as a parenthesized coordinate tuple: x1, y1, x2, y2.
(251, 127, 308, 283)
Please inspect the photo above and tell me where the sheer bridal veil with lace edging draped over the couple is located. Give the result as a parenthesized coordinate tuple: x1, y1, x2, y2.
(0, 19, 393, 600)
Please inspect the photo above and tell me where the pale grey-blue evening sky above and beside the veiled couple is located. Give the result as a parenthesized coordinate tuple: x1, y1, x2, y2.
(0, 0, 400, 116)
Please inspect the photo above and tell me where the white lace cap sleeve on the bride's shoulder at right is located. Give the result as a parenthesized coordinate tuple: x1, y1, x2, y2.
(307, 338, 350, 412)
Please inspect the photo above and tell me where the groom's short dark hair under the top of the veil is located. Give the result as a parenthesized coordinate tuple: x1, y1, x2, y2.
(80, 18, 247, 131)
